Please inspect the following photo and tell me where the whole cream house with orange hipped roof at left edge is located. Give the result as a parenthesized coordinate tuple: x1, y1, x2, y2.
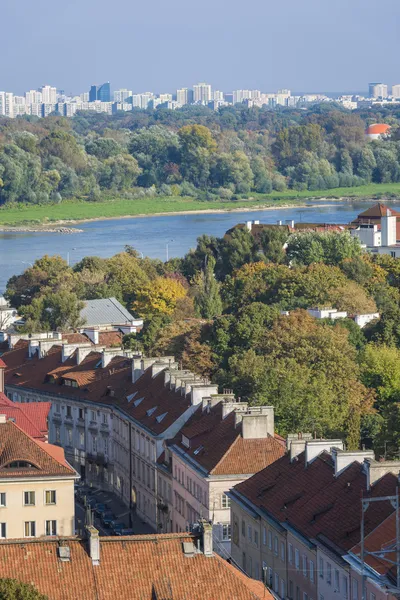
(0, 418, 79, 538)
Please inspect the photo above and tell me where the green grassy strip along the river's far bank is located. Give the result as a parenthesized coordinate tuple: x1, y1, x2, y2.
(0, 183, 400, 228)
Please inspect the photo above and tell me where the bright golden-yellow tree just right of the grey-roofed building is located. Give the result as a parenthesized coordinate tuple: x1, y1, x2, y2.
(132, 277, 187, 318)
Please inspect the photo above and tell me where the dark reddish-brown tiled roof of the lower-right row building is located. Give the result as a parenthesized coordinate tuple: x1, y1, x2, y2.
(233, 452, 397, 551)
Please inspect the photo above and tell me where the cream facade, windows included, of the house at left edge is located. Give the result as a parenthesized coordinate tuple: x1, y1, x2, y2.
(0, 477, 75, 538)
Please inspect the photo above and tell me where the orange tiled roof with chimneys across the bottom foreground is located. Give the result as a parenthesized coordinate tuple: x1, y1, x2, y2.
(0, 534, 272, 600)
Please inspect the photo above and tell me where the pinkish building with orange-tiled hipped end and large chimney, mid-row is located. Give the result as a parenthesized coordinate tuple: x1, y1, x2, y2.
(166, 398, 285, 558)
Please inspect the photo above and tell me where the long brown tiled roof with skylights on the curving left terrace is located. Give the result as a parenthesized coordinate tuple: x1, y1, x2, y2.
(4, 345, 195, 435)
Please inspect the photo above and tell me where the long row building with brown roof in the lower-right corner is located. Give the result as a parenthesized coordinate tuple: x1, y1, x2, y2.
(228, 436, 400, 600)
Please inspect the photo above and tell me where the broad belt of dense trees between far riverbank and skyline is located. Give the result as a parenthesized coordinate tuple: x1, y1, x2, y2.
(0, 106, 400, 204)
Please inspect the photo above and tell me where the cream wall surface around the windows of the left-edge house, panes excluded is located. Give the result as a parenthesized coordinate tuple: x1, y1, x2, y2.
(0, 477, 75, 538)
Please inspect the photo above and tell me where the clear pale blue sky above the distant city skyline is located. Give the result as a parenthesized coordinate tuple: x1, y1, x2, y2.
(0, 0, 400, 94)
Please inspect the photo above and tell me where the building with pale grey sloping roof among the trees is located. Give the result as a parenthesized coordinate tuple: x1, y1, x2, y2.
(80, 298, 143, 333)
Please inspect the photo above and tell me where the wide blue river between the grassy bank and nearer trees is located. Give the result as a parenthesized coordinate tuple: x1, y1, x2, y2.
(0, 200, 394, 293)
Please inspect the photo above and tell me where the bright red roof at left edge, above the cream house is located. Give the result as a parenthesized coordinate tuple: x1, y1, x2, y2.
(0, 393, 51, 441)
